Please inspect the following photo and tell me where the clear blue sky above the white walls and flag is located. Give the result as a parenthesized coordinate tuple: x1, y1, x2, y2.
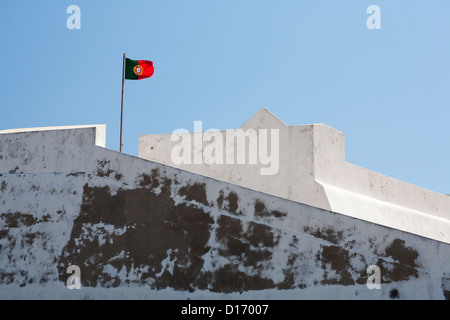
(0, 0, 450, 193)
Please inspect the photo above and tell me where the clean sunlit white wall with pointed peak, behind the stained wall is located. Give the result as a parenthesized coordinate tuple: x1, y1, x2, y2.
(139, 108, 450, 243)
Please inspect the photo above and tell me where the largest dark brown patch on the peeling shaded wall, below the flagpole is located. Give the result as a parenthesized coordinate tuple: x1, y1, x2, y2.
(58, 185, 213, 291)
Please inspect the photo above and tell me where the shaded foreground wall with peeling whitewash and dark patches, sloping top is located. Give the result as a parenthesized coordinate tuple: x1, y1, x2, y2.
(0, 126, 450, 299)
